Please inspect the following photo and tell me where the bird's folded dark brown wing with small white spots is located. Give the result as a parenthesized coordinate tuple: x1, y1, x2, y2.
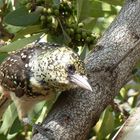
(0, 55, 28, 97)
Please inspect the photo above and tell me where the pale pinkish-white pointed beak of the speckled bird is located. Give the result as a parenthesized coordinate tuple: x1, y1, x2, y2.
(70, 74, 92, 91)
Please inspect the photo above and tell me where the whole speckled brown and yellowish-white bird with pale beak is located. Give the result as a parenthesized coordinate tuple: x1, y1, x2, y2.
(0, 42, 92, 123)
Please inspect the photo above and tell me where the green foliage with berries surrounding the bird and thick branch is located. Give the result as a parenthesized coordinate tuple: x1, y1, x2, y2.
(0, 0, 140, 140)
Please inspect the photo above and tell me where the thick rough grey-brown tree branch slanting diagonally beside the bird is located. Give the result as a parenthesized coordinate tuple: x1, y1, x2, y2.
(32, 0, 140, 140)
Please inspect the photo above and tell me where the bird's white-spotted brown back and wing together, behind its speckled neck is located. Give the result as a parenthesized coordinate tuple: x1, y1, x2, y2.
(0, 44, 45, 97)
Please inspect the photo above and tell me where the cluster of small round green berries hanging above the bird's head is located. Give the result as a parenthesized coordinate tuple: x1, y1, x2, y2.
(21, 0, 95, 47)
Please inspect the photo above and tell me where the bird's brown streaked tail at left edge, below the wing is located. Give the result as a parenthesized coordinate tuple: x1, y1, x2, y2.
(0, 94, 11, 119)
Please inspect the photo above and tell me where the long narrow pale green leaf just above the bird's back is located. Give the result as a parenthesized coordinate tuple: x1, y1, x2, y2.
(0, 33, 42, 53)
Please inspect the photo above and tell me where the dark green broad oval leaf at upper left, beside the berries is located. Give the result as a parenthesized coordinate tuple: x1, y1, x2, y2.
(4, 7, 40, 26)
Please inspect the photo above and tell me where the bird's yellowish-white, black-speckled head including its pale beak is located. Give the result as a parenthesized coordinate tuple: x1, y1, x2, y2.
(43, 47, 92, 91)
